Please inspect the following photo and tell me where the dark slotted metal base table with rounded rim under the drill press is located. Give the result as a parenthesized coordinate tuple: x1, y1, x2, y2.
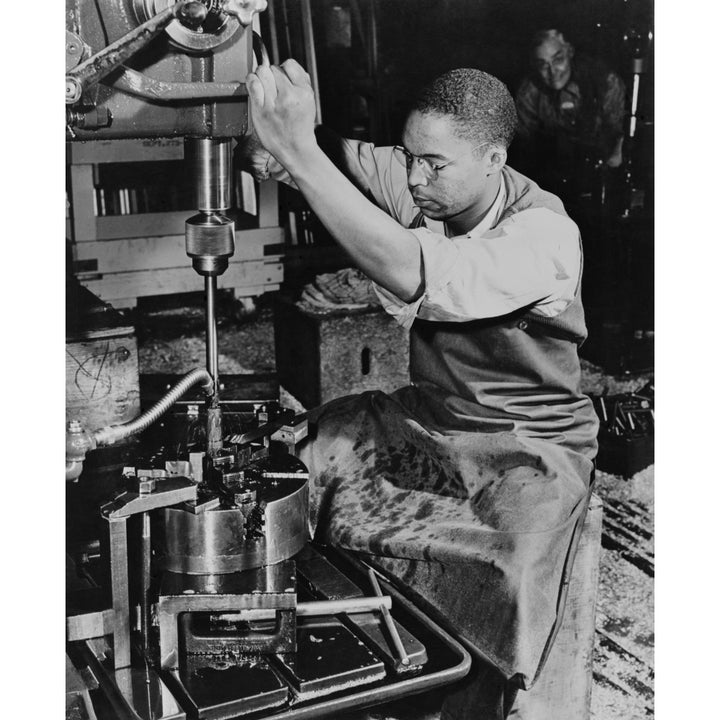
(71, 546, 470, 720)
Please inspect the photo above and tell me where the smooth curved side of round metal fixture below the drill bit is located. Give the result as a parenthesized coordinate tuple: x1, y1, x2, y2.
(162, 478, 309, 574)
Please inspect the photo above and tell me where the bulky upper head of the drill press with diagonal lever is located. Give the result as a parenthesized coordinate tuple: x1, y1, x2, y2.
(66, 0, 253, 140)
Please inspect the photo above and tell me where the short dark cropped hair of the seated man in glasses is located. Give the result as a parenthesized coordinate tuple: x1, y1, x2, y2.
(411, 68, 517, 148)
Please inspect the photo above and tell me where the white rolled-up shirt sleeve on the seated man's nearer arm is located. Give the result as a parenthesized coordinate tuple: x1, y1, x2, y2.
(375, 208, 581, 327)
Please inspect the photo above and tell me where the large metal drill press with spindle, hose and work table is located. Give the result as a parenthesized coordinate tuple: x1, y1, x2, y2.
(66, 0, 469, 720)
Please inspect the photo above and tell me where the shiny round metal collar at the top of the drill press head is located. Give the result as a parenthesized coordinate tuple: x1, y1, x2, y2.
(133, 0, 242, 52)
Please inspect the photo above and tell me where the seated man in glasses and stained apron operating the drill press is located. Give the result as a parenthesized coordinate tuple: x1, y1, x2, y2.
(243, 60, 597, 720)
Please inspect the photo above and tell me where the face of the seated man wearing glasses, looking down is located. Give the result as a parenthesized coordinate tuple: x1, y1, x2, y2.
(402, 111, 496, 221)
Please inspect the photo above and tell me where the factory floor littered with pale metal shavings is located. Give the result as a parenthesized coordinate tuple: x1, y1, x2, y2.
(133, 294, 654, 720)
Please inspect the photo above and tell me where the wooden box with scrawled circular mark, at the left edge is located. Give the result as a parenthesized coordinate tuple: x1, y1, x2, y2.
(65, 283, 140, 430)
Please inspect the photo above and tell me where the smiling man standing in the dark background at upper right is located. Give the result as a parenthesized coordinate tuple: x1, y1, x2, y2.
(512, 30, 627, 204)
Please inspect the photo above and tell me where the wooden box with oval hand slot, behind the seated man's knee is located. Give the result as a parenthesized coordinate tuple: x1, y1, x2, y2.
(275, 298, 410, 409)
